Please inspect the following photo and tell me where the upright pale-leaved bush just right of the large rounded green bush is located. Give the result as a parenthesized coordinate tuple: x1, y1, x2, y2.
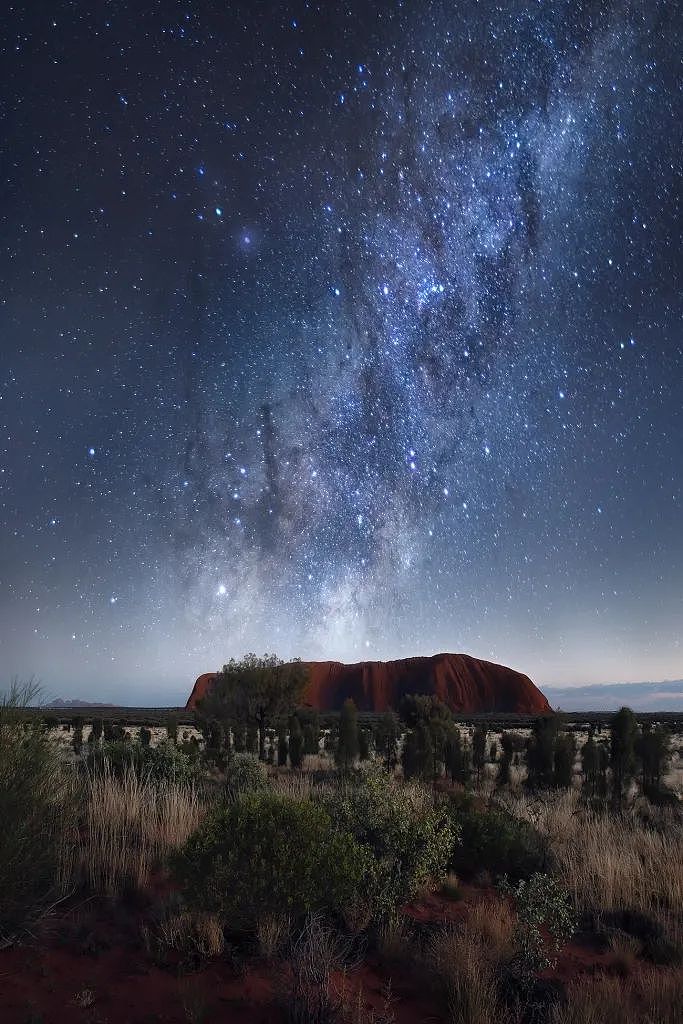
(328, 767, 459, 914)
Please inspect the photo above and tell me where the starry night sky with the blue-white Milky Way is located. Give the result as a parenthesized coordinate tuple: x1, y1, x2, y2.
(0, 0, 683, 705)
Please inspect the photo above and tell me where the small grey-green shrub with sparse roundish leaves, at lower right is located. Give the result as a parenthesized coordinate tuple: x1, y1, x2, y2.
(500, 871, 577, 977)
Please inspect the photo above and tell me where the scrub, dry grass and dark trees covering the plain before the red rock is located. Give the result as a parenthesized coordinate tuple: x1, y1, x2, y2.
(0, 666, 683, 1024)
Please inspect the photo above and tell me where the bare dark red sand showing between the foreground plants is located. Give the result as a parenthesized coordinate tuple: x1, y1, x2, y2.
(0, 885, 626, 1024)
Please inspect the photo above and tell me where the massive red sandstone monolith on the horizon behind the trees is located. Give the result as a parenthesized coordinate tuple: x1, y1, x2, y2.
(187, 654, 551, 715)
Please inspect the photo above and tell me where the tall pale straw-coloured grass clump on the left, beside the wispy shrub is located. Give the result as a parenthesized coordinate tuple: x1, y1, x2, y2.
(72, 764, 204, 895)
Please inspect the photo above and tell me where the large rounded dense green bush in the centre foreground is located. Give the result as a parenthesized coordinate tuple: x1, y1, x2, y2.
(173, 791, 374, 930)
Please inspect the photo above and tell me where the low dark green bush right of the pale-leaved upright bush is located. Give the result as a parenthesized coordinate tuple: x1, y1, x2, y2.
(447, 797, 548, 879)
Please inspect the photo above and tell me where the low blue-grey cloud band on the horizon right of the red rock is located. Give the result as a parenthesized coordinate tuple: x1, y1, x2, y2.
(544, 679, 683, 712)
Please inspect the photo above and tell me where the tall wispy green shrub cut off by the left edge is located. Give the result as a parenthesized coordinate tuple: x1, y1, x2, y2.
(0, 687, 75, 946)
